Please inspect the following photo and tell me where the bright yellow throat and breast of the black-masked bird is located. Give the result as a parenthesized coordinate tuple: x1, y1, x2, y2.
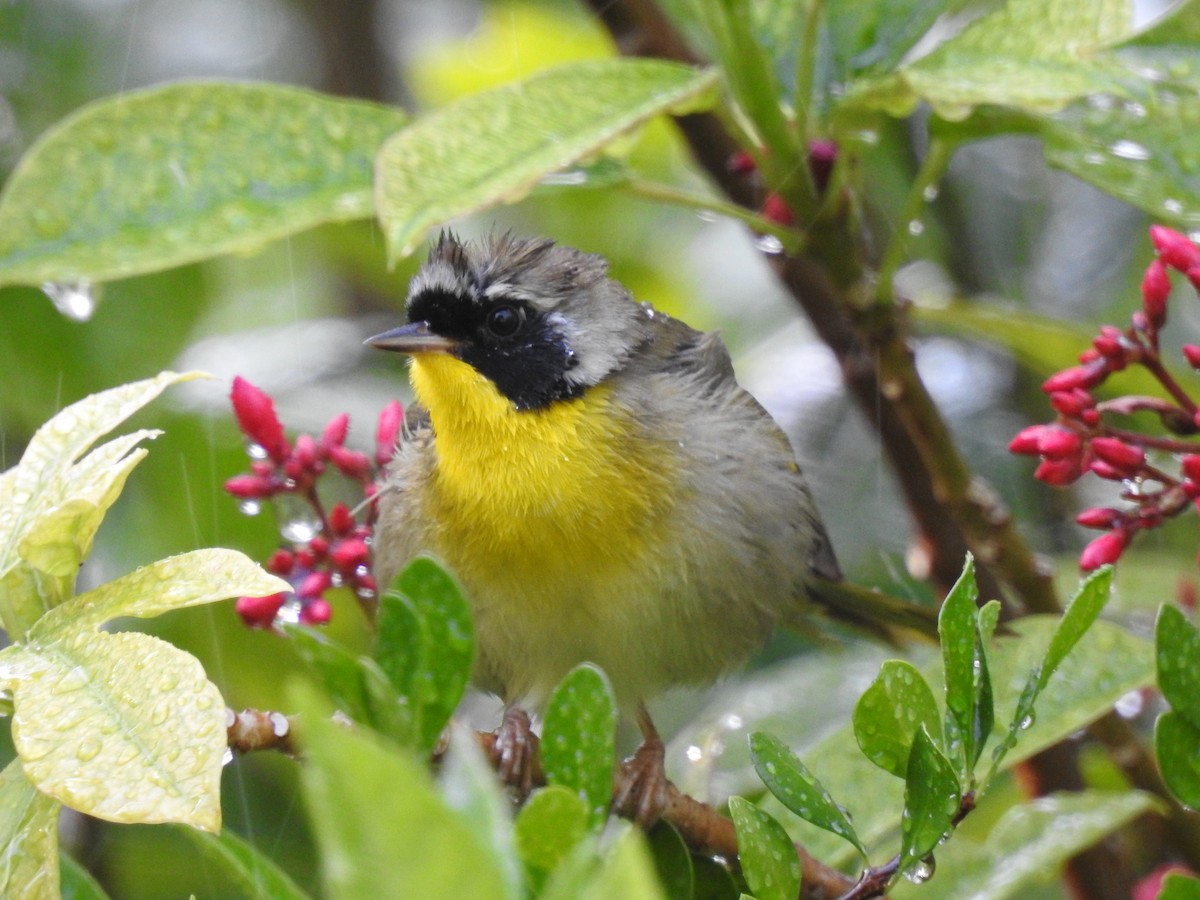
(412, 353, 672, 607)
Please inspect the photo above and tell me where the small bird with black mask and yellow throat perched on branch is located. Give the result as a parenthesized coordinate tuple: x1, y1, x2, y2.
(367, 232, 907, 821)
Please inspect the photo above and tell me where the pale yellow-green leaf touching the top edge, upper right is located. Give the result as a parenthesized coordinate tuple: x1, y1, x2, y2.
(876, 0, 1133, 120)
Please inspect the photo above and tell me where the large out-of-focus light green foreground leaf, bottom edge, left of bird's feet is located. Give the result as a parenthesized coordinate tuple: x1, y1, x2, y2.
(292, 685, 515, 900)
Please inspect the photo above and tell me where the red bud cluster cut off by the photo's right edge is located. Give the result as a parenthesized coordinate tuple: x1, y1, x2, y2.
(1008, 226, 1200, 570)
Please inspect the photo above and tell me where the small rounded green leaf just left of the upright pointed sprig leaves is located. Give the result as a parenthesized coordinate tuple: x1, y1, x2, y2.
(853, 660, 942, 778)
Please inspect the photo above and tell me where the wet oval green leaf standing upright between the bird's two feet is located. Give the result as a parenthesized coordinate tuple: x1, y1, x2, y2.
(541, 662, 617, 830)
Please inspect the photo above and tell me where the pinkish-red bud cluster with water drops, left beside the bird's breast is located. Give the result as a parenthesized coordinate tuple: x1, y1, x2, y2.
(224, 377, 403, 628)
